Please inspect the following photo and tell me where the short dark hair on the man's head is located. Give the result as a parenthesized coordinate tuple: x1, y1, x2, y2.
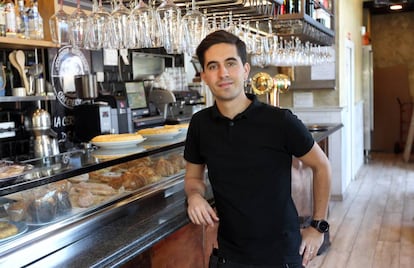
(196, 30, 247, 70)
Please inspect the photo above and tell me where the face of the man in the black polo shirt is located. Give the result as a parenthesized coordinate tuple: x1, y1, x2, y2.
(201, 43, 250, 100)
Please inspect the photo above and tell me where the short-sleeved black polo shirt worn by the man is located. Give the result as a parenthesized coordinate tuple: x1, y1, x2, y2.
(184, 95, 314, 265)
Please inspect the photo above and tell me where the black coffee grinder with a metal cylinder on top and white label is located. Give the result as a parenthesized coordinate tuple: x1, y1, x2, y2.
(73, 74, 112, 142)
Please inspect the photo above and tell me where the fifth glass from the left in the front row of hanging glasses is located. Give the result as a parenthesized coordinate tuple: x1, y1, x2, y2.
(130, 0, 162, 48)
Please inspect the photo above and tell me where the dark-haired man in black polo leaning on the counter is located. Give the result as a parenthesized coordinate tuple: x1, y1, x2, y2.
(184, 30, 331, 268)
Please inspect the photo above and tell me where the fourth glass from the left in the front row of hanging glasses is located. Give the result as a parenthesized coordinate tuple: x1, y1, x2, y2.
(111, 0, 135, 49)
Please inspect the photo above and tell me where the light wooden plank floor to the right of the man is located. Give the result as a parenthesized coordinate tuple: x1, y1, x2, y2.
(307, 153, 414, 268)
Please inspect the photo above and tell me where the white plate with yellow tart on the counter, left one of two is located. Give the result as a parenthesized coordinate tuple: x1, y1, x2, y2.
(91, 133, 146, 149)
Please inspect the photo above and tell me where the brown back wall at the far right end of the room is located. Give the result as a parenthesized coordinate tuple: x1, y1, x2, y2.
(370, 12, 414, 152)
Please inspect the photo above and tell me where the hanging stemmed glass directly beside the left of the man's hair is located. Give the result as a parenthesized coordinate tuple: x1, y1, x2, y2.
(181, 0, 207, 56)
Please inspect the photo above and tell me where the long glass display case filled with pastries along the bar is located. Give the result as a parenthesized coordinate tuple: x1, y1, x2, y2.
(0, 137, 185, 266)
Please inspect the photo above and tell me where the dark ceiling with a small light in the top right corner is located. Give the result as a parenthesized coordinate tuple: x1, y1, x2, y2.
(363, 0, 414, 15)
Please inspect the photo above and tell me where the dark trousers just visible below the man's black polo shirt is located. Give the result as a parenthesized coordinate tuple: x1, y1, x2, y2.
(208, 249, 303, 268)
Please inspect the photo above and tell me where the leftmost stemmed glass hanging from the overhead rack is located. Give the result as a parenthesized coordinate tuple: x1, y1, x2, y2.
(49, 0, 70, 45)
